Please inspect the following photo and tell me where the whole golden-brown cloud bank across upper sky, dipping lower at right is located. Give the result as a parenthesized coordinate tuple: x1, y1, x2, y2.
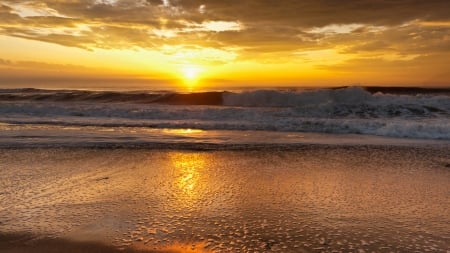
(0, 0, 450, 86)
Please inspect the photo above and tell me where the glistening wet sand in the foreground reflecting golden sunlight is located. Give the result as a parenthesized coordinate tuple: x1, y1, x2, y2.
(0, 145, 450, 252)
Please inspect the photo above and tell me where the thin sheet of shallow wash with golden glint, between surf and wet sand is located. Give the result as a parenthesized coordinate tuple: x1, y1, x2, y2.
(0, 128, 450, 151)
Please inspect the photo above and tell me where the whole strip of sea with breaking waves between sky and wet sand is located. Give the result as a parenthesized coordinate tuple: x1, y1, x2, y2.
(0, 87, 450, 147)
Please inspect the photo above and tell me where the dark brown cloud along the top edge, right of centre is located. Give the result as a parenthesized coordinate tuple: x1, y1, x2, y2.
(176, 0, 450, 27)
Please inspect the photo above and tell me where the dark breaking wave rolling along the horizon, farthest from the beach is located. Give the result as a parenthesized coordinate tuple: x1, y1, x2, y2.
(0, 87, 450, 107)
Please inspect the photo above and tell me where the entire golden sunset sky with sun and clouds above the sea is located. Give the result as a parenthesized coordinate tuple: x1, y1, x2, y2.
(0, 0, 450, 89)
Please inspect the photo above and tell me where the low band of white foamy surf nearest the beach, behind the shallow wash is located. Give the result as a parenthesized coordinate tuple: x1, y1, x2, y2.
(0, 114, 450, 140)
